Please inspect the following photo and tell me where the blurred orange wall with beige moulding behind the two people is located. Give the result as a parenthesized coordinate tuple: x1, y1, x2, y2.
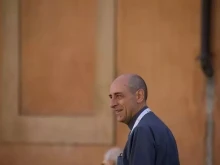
(0, 0, 220, 165)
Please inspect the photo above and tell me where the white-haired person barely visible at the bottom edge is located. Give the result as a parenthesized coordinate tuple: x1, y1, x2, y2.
(102, 147, 122, 165)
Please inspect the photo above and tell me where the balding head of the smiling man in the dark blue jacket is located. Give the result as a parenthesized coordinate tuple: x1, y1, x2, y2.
(109, 74, 147, 124)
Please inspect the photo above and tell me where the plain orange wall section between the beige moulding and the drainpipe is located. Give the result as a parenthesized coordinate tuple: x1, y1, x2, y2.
(117, 0, 205, 165)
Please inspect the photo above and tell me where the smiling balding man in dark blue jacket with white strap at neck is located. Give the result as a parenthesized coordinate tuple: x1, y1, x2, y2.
(109, 74, 180, 165)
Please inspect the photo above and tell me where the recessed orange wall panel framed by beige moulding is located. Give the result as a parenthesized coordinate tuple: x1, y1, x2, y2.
(19, 0, 98, 116)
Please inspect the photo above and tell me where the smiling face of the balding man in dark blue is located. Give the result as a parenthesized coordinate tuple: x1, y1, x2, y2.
(109, 77, 138, 124)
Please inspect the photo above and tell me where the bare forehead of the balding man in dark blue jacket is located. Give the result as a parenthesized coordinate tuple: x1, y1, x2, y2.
(110, 79, 129, 94)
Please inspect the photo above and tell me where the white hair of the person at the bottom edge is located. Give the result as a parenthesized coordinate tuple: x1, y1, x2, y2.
(104, 147, 122, 164)
